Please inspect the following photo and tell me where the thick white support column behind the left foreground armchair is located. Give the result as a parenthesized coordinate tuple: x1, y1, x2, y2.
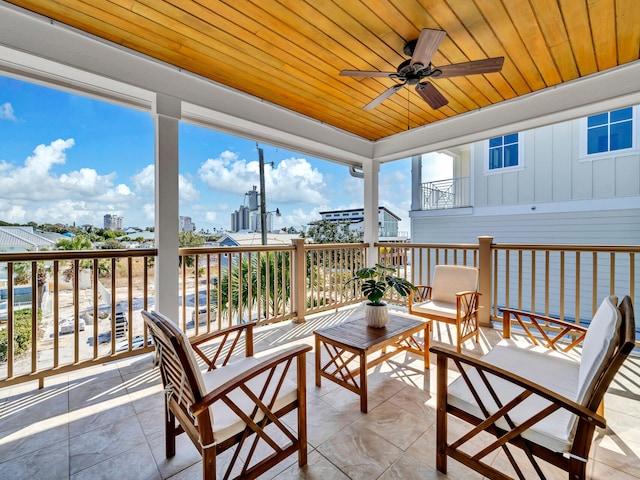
(153, 94, 181, 322)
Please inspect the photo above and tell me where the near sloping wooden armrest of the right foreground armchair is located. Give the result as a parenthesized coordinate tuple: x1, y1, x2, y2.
(429, 347, 607, 428)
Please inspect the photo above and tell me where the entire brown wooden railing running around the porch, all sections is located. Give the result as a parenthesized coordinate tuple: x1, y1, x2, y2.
(0, 237, 640, 387)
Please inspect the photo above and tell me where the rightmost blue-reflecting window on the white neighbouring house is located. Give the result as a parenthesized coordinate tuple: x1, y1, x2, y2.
(587, 107, 633, 155)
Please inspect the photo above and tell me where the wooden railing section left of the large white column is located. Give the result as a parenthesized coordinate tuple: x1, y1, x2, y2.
(0, 249, 157, 386)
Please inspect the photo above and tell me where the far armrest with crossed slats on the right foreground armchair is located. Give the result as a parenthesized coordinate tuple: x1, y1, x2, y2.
(499, 308, 587, 352)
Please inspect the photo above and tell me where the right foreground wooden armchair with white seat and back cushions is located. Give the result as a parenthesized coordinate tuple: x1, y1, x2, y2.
(431, 296, 635, 480)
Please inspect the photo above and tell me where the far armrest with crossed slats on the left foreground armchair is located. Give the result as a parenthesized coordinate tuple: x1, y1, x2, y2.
(189, 322, 255, 370)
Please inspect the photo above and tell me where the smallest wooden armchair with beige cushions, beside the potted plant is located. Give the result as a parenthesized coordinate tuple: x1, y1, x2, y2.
(409, 265, 480, 353)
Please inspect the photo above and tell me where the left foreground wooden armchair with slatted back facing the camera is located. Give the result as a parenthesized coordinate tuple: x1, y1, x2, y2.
(142, 311, 311, 479)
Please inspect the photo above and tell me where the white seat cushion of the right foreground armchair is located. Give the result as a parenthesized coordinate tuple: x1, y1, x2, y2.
(448, 342, 580, 452)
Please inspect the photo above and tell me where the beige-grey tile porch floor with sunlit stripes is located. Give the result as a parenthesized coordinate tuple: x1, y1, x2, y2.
(0, 308, 640, 480)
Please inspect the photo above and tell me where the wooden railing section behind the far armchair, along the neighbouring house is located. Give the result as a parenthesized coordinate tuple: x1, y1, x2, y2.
(376, 237, 640, 346)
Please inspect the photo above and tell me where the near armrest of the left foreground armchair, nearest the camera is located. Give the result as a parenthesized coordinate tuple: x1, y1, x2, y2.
(189, 345, 312, 416)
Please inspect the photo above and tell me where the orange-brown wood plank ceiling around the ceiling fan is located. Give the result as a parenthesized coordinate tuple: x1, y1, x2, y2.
(9, 0, 640, 140)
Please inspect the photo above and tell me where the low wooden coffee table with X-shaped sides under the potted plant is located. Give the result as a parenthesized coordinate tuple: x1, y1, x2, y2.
(313, 313, 431, 413)
